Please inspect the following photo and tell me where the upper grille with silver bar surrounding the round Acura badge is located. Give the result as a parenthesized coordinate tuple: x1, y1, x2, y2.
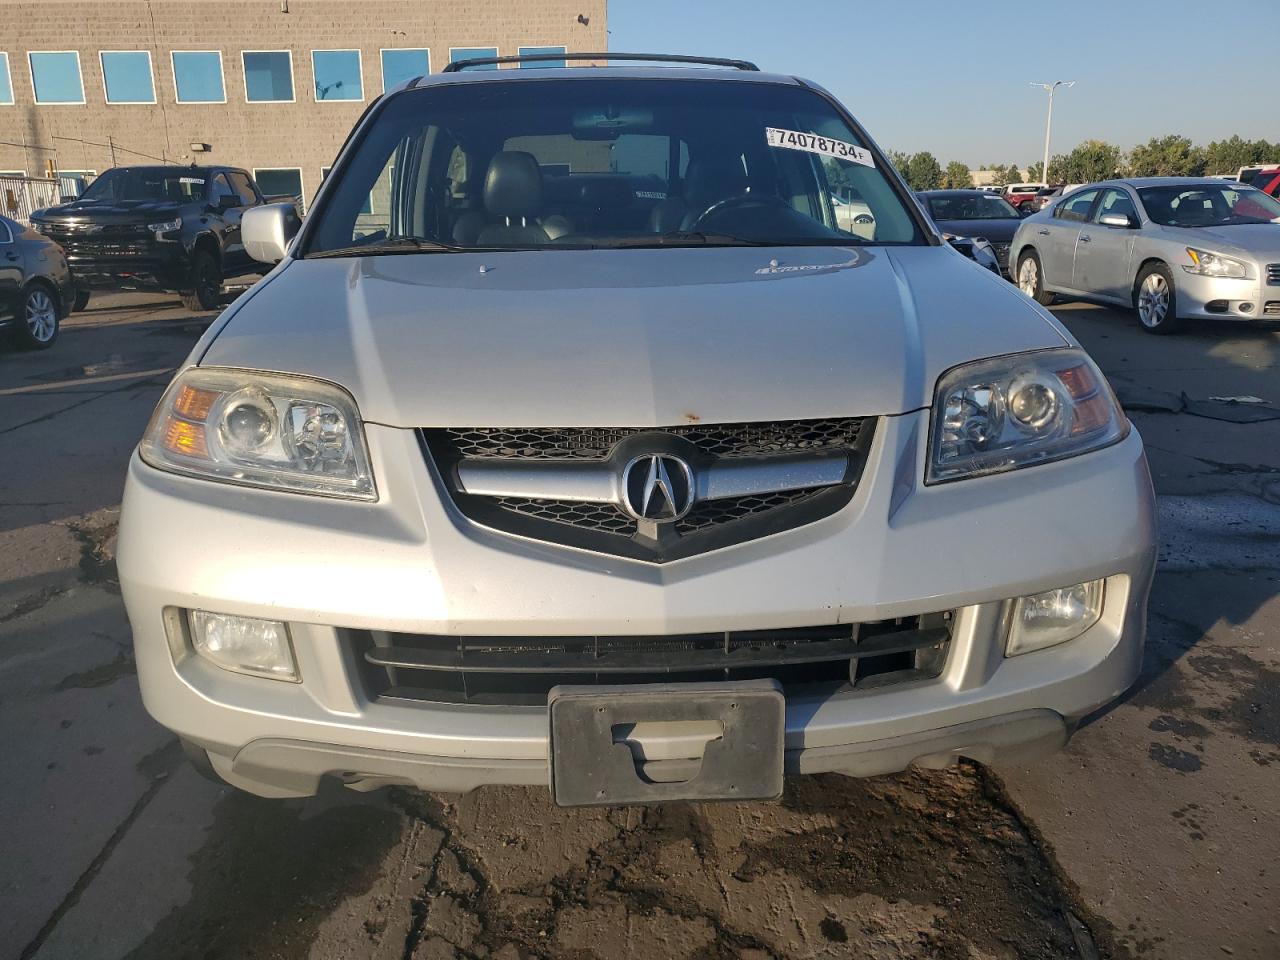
(421, 417, 874, 563)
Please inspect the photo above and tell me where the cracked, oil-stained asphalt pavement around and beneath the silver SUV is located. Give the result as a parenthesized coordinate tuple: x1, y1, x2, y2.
(0, 294, 1280, 960)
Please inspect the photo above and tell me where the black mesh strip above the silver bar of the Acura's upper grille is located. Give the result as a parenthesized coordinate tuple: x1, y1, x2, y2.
(428, 417, 863, 460)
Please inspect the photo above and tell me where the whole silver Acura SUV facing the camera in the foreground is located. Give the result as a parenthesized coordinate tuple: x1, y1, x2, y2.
(118, 52, 1156, 805)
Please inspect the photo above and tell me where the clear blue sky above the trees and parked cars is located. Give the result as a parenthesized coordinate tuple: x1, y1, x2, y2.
(608, 0, 1280, 166)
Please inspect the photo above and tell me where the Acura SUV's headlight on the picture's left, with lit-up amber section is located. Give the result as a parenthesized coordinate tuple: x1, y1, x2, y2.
(138, 367, 378, 500)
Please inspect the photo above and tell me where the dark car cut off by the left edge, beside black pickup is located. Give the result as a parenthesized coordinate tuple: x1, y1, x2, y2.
(0, 216, 76, 349)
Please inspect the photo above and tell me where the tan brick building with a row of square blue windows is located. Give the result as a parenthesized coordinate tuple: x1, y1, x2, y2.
(0, 0, 607, 207)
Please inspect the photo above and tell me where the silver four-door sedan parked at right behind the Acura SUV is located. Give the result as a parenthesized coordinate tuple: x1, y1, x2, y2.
(1012, 177, 1280, 333)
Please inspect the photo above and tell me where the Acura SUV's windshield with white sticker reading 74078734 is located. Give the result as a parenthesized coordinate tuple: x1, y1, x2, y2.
(305, 78, 924, 256)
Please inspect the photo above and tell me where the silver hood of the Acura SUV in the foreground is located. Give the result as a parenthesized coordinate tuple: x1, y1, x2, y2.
(197, 247, 1066, 426)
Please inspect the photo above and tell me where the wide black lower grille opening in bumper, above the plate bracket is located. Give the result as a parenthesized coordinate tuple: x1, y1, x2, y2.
(344, 612, 952, 705)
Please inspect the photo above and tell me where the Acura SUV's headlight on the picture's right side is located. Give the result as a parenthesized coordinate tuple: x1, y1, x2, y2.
(925, 349, 1129, 484)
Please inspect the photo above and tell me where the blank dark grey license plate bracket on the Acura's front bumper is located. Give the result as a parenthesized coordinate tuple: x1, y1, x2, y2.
(547, 680, 786, 806)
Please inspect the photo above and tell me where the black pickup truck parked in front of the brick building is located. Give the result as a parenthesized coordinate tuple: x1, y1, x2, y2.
(31, 165, 275, 310)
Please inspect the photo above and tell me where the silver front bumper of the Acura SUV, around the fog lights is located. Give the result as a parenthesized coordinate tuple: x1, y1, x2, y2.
(118, 411, 1155, 796)
